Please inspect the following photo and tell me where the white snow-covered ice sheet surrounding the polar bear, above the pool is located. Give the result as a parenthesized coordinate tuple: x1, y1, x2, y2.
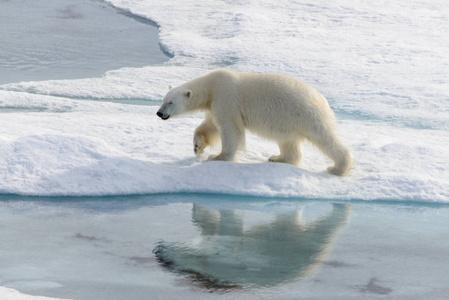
(0, 0, 449, 299)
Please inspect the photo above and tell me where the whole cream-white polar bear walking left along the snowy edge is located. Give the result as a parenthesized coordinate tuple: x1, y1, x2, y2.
(157, 69, 353, 175)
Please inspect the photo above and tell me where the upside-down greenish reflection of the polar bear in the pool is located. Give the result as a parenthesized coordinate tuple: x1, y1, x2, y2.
(153, 204, 351, 289)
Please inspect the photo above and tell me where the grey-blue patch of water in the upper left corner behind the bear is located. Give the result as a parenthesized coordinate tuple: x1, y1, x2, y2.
(0, 0, 168, 84)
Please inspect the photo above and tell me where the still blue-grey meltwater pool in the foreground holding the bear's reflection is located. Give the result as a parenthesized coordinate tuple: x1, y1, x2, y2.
(0, 195, 449, 299)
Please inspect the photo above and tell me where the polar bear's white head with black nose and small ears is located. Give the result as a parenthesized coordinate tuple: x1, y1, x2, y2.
(156, 86, 192, 120)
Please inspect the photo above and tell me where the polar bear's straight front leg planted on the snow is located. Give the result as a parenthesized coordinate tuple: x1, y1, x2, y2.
(209, 121, 245, 161)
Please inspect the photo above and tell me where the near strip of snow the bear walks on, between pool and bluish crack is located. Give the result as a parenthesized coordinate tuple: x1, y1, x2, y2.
(0, 91, 449, 202)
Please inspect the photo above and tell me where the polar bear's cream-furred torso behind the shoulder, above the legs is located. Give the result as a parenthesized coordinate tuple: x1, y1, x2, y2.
(214, 71, 335, 140)
